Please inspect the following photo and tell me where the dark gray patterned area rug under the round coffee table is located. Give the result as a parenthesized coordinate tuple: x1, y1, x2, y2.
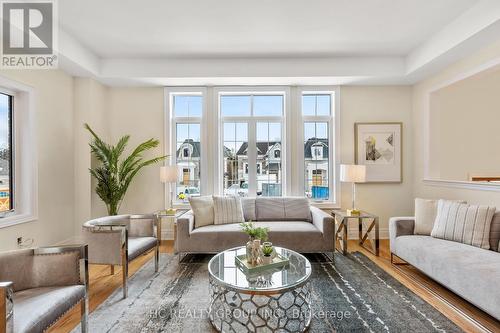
(74, 252, 461, 333)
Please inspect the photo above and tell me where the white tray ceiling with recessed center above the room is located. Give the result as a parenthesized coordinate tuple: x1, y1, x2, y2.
(53, 0, 500, 85)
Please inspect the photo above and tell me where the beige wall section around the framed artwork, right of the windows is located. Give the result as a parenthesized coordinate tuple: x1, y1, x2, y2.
(340, 86, 413, 238)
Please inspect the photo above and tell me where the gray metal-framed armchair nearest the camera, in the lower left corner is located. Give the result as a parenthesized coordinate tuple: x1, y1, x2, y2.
(0, 245, 89, 333)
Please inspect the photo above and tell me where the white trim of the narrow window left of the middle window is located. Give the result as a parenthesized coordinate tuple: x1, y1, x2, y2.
(164, 87, 210, 208)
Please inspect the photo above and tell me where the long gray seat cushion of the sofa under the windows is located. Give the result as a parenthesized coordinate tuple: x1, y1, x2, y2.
(189, 221, 333, 253)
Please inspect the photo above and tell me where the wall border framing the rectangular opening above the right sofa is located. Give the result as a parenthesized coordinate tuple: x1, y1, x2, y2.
(412, 42, 500, 207)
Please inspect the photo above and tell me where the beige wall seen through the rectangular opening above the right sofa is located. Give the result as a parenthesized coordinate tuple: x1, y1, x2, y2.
(430, 68, 500, 181)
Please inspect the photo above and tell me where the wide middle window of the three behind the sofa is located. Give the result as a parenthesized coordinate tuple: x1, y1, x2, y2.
(218, 91, 285, 196)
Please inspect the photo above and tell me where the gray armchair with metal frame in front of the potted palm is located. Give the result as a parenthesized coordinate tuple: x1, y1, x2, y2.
(83, 214, 161, 298)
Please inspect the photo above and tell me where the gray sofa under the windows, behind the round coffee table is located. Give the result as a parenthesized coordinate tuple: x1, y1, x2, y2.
(175, 197, 334, 253)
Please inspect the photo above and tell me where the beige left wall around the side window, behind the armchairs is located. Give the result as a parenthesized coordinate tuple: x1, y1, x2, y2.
(0, 70, 75, 251)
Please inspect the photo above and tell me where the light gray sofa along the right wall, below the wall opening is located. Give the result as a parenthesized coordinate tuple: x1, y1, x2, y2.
(389, 212, 500, 320)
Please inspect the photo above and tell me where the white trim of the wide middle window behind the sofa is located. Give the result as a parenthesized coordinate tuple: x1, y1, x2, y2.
(213, 86, 291, 196)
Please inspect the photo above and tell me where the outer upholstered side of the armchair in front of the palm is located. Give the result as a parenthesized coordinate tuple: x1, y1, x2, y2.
(82, 224, 128, 265)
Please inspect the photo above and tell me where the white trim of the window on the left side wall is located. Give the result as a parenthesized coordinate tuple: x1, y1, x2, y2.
(0, 77, 38, 228)
